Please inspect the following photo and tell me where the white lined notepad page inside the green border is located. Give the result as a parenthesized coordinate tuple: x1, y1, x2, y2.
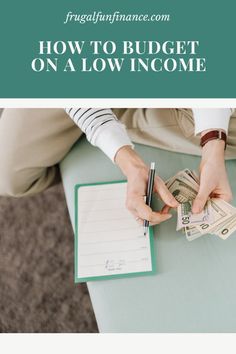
(76, 183, 152, 278)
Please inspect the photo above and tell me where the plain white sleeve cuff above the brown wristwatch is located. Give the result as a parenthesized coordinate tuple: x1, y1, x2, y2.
(193, 108, 232, 135)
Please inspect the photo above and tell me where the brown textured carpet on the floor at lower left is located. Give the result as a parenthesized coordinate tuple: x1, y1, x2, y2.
(0, 184, 97, 333)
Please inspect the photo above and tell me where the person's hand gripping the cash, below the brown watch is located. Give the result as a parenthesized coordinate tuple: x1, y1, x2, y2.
(192, 136, 232, 213)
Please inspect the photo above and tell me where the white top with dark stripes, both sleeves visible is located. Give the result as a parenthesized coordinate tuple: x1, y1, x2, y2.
(66, 108, 232, 161)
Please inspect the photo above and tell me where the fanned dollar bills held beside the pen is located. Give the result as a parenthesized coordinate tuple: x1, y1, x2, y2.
(166, 169, 236, 241)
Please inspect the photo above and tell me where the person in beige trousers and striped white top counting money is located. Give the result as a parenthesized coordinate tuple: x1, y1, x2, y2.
(0, 108, 236, 224)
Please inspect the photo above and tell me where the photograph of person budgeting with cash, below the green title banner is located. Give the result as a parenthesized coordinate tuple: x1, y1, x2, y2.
(0, 107, 236, 333)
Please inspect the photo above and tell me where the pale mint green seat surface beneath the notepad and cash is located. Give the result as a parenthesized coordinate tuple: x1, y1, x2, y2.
(60, 138, 236, 332)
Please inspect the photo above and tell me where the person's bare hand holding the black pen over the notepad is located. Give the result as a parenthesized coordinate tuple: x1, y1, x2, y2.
(115, 146, 178, 224)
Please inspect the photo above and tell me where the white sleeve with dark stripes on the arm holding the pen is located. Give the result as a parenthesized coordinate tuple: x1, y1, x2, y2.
(66, 108, 133, 162)
